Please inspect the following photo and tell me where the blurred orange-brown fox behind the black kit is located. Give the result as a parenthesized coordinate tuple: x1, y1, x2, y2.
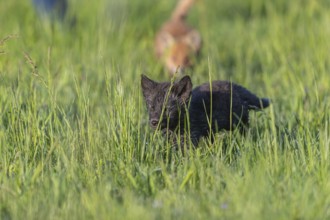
(155, 0, 202, 74)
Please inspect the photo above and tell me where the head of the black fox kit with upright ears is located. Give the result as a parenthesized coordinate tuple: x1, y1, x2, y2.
(141, 75, 192, 131)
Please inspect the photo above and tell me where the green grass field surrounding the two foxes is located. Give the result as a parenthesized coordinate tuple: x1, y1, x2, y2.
(0, 0, 330, 219)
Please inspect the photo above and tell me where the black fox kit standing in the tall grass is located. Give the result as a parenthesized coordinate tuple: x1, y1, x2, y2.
(141, 75, 270, 146)
